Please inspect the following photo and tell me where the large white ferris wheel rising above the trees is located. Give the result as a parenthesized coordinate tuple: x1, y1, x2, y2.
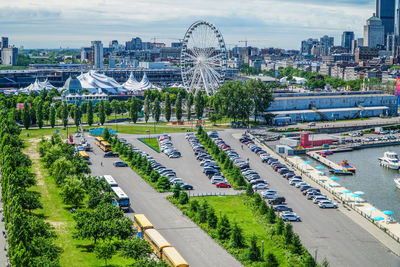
(180, 20, 227, 95)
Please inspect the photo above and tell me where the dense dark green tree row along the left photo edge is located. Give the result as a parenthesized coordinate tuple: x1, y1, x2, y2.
(0, 104, 61, 266)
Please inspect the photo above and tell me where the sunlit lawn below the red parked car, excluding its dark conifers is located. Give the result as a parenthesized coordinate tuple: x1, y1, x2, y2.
(172, 194, 301, 266)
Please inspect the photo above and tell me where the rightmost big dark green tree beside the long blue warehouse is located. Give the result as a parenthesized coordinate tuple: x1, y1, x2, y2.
(246, 79, 274, 122)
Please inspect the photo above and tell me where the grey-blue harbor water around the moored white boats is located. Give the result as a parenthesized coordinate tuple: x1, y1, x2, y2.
(307, 146, 400, 221)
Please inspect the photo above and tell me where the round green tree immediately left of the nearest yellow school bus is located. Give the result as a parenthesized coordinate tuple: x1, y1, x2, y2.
(121, 237, 153, 261)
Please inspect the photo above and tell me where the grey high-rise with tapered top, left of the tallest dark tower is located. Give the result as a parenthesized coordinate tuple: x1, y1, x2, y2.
(364, 14, 385, 48)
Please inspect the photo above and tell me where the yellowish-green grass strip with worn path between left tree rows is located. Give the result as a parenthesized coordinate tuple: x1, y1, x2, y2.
(24, 138, 131, 267)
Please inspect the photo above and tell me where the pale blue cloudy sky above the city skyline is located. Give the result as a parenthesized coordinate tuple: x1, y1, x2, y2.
(0, 0, 376, 49)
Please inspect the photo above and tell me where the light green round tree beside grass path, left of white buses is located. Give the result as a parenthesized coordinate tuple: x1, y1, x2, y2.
(61, 176, 85, 208)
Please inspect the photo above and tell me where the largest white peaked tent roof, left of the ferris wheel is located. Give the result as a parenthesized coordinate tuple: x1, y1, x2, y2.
(77, 70, 126, 94)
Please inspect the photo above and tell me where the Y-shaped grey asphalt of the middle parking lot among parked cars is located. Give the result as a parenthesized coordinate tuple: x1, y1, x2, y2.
(118, 133, 237, 194)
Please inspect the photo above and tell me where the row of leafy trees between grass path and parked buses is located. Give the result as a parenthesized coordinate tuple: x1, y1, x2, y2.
(39, 135, 167, 267)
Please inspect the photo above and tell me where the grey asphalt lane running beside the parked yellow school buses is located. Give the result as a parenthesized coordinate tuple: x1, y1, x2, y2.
(87, 137, 242, 267)
